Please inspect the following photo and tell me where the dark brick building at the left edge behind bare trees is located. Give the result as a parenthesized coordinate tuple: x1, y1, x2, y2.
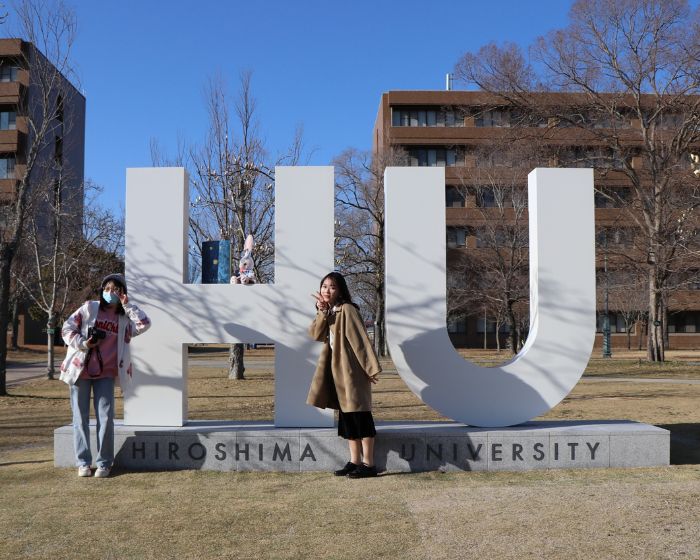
(0, 39, 85, 345)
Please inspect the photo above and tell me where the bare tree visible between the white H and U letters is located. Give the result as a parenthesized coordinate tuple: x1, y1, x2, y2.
(333, 144, 407, 356)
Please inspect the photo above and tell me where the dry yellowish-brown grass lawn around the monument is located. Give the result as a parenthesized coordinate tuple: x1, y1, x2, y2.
(0, 351, 700, 559)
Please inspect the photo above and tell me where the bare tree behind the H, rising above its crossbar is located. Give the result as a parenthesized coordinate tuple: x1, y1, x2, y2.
(151, 72, 303, 379)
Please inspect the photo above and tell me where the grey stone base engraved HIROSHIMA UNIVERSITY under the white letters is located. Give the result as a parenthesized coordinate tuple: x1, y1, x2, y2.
(54, 420, 670, 472)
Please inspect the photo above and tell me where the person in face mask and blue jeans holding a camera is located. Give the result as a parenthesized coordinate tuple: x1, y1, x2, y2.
(60, 274, 151, 478)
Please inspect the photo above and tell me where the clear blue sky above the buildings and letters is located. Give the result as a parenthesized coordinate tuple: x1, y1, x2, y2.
(9, 0, 571, 210)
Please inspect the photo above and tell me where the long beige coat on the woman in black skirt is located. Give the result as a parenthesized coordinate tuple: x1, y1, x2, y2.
(306, 303, 382, 412)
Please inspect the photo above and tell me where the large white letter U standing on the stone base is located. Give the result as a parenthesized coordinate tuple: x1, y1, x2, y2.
(385, 168, 595, 426)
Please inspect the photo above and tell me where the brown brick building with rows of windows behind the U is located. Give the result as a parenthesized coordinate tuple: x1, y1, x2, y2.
(373, 91, 700, 349)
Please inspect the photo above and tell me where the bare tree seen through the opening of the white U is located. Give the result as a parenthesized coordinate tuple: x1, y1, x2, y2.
(448, 136, 537, 353)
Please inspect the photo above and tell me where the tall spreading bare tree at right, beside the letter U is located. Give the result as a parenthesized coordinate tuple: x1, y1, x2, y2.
(456, 0, 700, 361)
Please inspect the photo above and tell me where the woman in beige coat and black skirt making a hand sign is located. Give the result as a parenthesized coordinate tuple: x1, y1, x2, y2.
(306, 272, 382, 478)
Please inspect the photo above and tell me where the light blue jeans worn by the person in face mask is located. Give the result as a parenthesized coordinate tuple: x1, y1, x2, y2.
(70, 377, 114, 468)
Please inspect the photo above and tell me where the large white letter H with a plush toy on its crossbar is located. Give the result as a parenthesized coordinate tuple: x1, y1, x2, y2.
(124, 167, 333, 427)
